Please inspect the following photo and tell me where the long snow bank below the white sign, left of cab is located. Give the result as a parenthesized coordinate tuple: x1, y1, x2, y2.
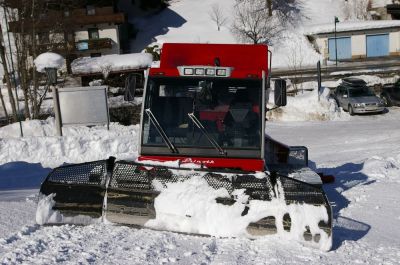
(0, 118, 139, 168)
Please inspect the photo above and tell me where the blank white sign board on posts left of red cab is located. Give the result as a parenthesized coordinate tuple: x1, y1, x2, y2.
(57, 86, 110, 126)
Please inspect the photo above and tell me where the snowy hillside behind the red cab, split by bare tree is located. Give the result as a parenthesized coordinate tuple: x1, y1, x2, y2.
(130, 0, 344, 68)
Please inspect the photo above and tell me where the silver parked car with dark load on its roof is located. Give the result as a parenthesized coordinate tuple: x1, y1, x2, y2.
(334, 78, 385, 115)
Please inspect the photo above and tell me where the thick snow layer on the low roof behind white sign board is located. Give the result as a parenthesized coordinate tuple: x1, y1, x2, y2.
(71, 53, 153, 75)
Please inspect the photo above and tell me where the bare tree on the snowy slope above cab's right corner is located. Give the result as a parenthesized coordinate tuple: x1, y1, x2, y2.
(232, 0, 282, 44)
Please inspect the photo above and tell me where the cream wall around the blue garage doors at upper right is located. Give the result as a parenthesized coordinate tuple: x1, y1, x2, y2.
(314, 28, 400, 60)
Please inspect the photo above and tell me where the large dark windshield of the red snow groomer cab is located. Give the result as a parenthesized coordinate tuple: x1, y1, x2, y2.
(143, 77, 262, 149)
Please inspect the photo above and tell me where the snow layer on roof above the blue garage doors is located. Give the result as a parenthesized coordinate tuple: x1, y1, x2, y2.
(306, 20, 400, 35)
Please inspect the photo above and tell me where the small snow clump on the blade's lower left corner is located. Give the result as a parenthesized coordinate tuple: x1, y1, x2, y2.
(36, 193, 101, 225)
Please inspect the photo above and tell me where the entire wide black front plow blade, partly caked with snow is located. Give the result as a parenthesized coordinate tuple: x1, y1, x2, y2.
(38, 159, 332, 250)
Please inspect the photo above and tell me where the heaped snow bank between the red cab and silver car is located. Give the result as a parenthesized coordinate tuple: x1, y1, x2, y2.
(267, 86, 350, 121)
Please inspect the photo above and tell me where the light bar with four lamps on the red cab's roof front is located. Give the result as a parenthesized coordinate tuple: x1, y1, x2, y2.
(178, 65, 233, 77)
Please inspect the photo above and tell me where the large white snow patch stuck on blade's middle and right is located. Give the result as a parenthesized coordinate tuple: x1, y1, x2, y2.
(145, 175, 332, 251)
